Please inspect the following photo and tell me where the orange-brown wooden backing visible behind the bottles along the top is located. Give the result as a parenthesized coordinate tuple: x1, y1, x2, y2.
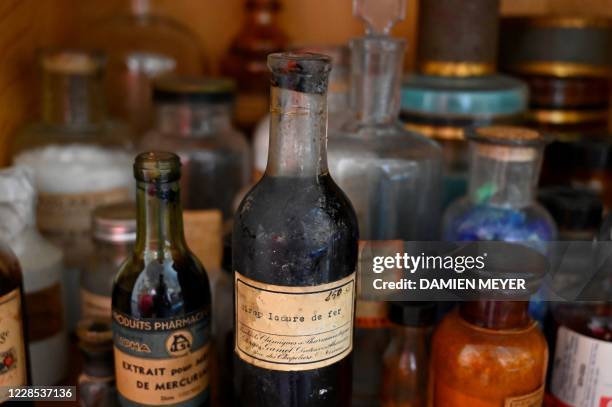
(0, 0, 612, 165)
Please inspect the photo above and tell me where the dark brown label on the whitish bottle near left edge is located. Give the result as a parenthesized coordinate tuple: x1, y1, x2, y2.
(25, 282, 64, 342)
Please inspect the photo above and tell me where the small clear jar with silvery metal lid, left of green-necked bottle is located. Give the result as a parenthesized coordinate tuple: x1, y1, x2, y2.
(81, 202, 136, 318)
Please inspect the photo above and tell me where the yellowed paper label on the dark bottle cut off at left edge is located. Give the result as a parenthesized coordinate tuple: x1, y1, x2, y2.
(0, 289, 27, 402)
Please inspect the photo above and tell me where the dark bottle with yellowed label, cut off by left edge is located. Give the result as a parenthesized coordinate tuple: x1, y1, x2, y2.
(0, 242, 30, 405)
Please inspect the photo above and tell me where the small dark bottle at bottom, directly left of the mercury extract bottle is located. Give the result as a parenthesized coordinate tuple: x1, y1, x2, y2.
(77, 314, 119, 407)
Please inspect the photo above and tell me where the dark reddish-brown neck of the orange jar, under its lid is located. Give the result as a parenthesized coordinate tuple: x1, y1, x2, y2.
(459, 300, 532, 330)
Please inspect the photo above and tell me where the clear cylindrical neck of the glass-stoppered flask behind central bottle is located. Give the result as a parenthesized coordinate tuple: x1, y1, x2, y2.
(351, 36, 405, 124)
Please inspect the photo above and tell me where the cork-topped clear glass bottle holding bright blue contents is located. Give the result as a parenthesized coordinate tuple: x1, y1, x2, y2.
(443, 126, 557, 252)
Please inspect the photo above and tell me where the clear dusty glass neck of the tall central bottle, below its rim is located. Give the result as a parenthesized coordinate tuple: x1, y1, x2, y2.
(266, 87, 328, 177)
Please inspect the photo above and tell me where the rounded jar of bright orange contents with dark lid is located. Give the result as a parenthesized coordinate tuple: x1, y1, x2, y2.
(430, 242, 548, 407)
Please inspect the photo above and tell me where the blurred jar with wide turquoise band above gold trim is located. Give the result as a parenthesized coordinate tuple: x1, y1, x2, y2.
(400, 74, 528, 207)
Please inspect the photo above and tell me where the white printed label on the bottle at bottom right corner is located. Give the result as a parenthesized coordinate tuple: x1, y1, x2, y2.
(551, 326, 612, 407)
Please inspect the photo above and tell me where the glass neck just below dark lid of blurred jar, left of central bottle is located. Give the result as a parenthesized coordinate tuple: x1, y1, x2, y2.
(155, 103, 231, 137)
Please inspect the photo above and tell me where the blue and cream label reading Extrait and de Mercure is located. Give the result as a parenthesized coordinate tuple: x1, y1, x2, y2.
(112, 310, 210, 407)
